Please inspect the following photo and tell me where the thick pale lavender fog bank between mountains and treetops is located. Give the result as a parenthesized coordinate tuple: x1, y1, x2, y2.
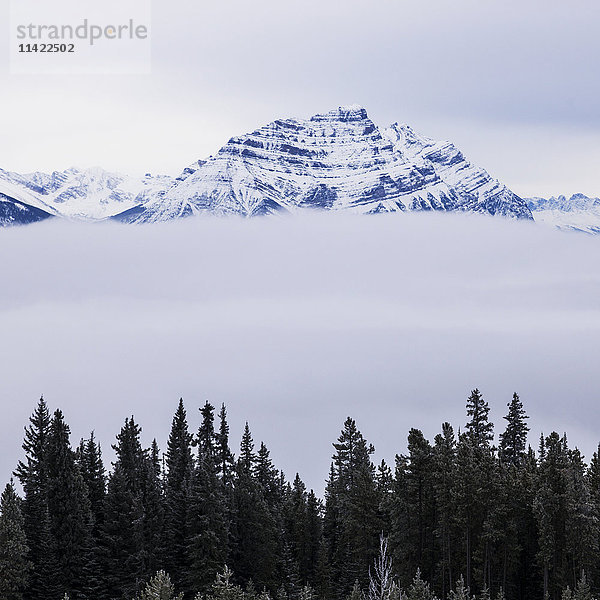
(0, 215, 600, 493)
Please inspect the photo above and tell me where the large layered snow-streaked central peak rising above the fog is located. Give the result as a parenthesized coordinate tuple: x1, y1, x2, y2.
(114, 105, 532, 223)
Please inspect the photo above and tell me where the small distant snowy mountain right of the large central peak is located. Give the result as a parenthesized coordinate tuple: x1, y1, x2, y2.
(527, 194, 600, 234)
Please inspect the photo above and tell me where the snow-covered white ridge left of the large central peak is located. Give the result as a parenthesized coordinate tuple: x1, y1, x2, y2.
(0, 168, 172, 220)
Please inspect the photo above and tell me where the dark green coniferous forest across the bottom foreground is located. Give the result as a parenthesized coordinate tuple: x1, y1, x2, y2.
(0, 389, 600, 600)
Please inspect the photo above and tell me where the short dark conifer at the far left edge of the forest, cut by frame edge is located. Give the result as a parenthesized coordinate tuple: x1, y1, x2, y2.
(0, 481, 31, 600)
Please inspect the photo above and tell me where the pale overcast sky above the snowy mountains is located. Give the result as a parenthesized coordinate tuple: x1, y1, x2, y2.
(0, 0, 600, 196)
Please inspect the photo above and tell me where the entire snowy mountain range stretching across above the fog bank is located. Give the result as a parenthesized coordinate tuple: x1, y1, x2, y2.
(0, 105, 600, 232)
